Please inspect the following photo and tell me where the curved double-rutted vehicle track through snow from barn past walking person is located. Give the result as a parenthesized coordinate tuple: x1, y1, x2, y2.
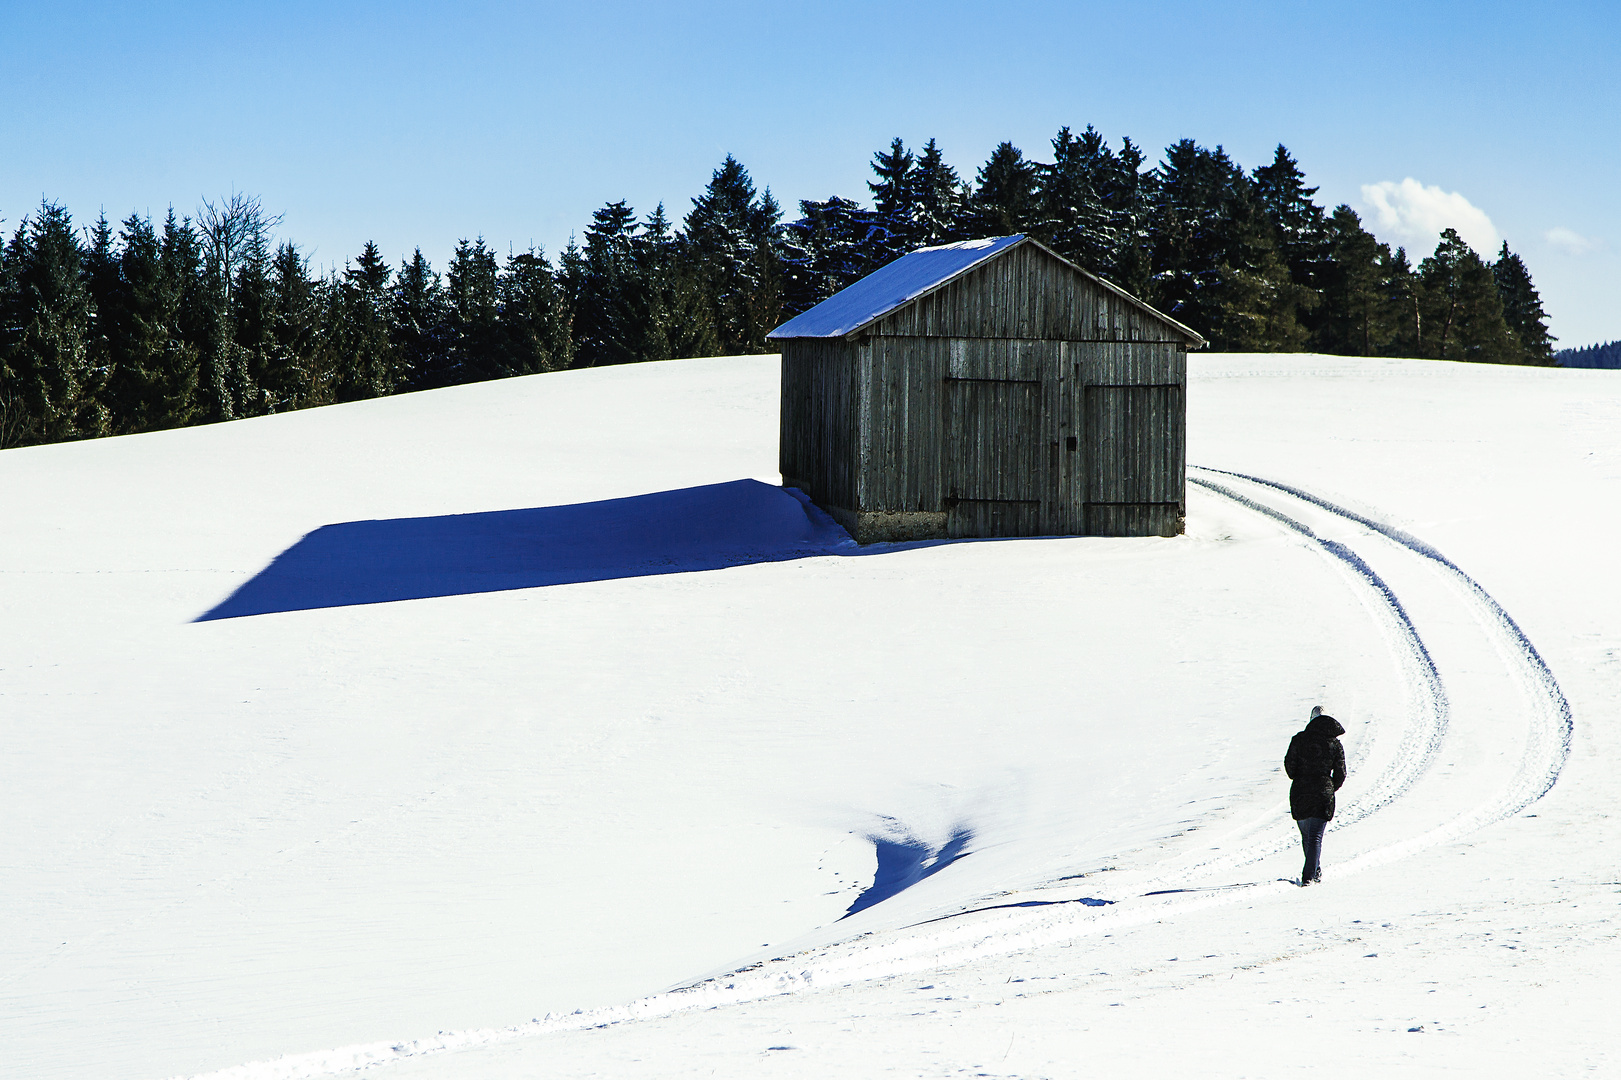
(177, 467, 1574, 1080)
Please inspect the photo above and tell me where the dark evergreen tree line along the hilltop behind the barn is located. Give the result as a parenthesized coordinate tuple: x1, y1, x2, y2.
(0, 128, 1555, 448)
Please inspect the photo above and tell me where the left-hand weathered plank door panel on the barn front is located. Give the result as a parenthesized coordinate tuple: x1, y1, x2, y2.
(945, 378, 1047, 537)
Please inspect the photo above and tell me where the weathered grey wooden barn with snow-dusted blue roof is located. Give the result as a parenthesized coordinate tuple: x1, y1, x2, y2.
(768, 237, 1204, 543)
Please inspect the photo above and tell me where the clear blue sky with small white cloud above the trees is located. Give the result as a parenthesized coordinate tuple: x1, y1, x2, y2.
(0, 0, 1621, 345)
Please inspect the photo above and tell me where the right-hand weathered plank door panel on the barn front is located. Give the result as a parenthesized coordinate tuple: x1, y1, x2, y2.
(1084, 386, 1183, 537)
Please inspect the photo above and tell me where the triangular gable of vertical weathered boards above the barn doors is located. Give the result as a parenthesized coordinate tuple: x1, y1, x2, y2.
(867, 243, 1188, 345)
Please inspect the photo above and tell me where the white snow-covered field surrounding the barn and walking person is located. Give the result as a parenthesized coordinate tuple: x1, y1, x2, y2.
(0, 355, 1621, 1080)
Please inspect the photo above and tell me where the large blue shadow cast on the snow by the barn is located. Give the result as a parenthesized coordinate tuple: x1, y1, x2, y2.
(196, 480, 939, 623)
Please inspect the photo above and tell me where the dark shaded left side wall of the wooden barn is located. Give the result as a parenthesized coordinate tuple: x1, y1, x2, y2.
(778, 339, 859, 508)
